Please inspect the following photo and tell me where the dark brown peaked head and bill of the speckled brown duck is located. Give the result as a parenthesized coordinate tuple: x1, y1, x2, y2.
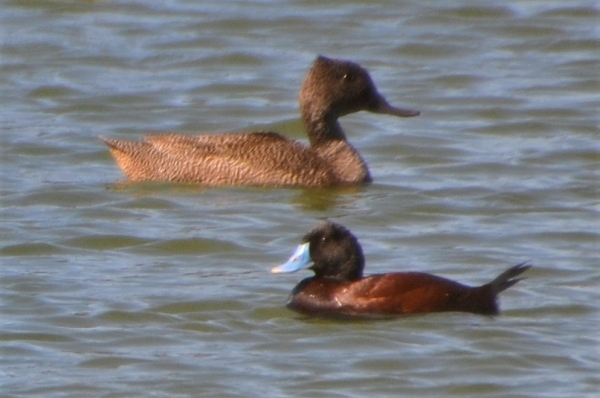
(300, 56, 419, 121)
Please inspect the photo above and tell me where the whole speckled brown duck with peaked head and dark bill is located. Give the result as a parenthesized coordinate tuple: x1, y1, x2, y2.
(102, 56, 419, 187)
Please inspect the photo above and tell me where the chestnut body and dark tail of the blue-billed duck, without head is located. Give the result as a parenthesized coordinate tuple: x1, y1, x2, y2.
(287, 264, 530, 317)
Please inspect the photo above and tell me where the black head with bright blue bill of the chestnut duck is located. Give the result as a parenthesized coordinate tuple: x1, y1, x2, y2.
(271, 222, 365, 281)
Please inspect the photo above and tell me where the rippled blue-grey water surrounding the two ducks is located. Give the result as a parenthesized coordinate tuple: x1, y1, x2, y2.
(0, 0, 600, 397)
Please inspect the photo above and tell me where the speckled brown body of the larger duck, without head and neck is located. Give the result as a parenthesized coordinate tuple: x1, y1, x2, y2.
(103, 132, 370, 187)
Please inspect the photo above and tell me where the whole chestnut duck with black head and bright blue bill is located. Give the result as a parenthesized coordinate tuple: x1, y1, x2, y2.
(271, 222, 531, 317)
